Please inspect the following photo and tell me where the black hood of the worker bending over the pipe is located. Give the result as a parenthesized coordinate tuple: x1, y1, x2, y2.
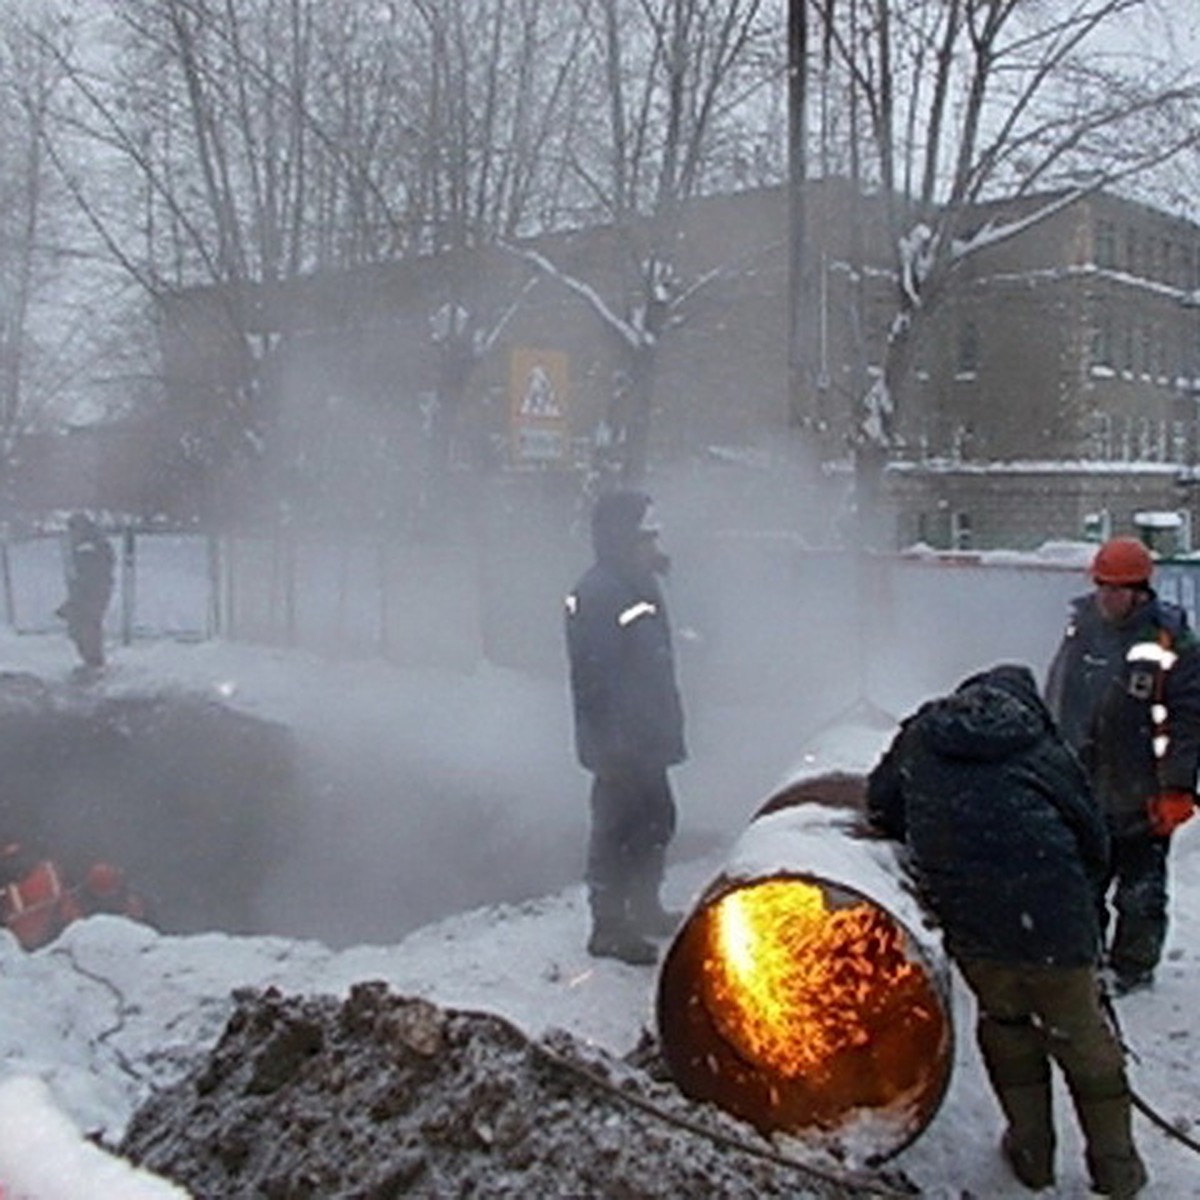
(922, 664, 1049, 762)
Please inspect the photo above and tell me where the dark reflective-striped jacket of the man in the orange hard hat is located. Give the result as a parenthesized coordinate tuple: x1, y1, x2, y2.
(1046, 593, 1200, 834)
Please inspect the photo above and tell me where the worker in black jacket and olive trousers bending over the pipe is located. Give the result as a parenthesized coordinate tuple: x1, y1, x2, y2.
(868, 665, 1146, 1196)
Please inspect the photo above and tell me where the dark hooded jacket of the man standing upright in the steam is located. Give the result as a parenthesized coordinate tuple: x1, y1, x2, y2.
(566, 493, 686, 775)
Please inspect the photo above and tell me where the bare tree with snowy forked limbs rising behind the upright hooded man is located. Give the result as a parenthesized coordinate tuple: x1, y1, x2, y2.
(513, 0, 782, 484)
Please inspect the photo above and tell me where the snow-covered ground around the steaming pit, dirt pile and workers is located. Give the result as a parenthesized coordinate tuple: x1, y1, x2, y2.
(0, 636, 1200, 1200)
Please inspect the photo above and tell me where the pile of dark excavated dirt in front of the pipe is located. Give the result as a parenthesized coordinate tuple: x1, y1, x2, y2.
(119, 983, 898, 1200)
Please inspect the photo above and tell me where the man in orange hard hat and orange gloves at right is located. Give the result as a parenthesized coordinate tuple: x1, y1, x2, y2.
(1046, 538, 1200, 994)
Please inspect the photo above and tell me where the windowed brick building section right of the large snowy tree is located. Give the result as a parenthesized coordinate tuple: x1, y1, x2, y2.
(889, 194, 1200, 548)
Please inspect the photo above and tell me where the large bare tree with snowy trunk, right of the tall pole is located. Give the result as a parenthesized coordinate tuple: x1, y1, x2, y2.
(812, 0, 1200, 540)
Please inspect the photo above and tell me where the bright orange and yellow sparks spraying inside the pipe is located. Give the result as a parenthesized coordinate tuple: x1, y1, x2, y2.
(703, 878, 940, 1094)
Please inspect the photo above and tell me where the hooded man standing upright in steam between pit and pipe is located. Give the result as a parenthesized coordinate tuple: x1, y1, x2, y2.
(566, 491, 686, 965)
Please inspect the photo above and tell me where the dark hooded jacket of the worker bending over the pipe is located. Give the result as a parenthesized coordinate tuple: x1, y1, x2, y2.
(868, 666, 1109, 966)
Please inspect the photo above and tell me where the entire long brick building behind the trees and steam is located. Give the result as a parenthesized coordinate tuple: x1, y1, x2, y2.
(154, 180, 1200, 547)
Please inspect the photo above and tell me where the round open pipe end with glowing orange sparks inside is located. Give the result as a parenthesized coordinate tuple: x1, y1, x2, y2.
(659, 875, 952, 1158)
